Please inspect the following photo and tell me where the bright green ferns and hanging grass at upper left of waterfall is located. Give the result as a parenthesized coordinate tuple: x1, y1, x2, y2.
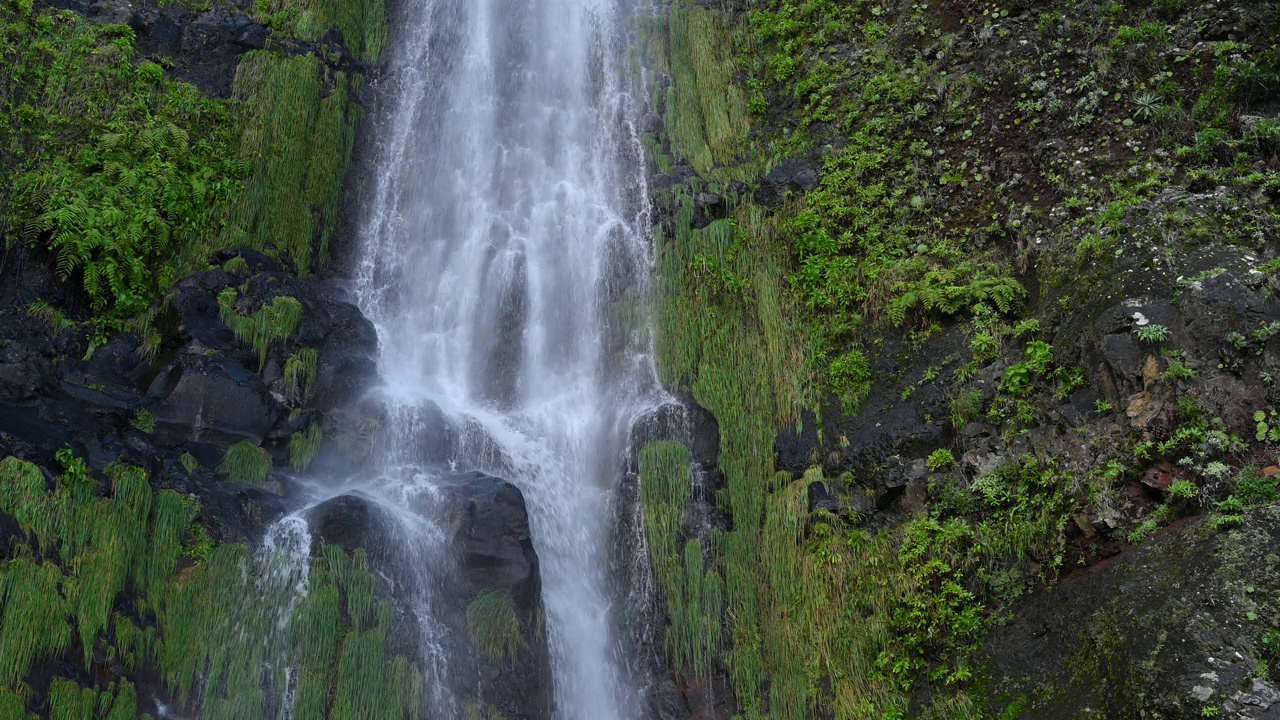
(0, 0, 387, 320)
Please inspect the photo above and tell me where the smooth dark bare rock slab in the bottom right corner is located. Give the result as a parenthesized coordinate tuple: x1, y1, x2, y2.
(982, 507, 1280, 720)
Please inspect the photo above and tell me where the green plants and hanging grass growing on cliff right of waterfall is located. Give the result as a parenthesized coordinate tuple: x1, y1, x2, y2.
(640, 0, 1280, 719)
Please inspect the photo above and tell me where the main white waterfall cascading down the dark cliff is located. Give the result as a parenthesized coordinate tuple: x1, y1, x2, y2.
(356, 0, 660, 720)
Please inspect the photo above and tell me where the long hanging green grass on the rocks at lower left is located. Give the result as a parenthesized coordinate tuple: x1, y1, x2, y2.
(0, 451, 421, 720)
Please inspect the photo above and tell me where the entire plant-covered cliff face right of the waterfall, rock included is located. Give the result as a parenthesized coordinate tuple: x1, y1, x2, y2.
(632, 0, 1280, 720)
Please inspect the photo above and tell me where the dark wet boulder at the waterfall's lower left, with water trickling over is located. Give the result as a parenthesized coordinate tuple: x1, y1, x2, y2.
(308, 473, 552, 720)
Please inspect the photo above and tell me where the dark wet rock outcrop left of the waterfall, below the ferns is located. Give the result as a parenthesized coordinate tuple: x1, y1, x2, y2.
(0, 244, 378, 527)
